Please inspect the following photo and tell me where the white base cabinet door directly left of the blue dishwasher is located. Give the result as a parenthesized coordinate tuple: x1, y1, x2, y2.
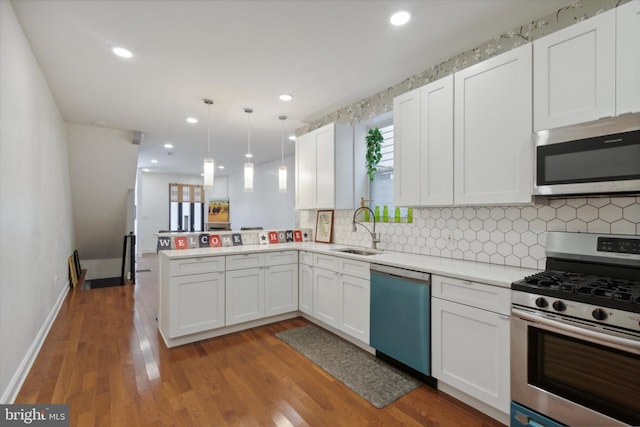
(339, 274, 371, 344)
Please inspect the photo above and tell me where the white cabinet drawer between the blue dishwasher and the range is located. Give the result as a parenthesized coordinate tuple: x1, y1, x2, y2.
(431, 275, 511, 315)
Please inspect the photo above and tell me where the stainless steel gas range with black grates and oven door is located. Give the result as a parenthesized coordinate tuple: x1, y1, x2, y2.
(511, 232, 640, 427)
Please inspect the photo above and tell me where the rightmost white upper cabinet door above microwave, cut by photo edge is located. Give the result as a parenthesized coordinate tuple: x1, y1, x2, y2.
(616, 0, 640, 115)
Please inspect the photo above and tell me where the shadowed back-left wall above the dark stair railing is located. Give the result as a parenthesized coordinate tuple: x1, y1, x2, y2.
(67, 123, 139, 280)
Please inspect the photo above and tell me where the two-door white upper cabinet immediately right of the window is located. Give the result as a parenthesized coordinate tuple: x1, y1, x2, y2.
(393, 76, 453, 206)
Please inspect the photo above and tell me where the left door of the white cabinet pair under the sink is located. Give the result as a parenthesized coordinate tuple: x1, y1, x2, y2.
(313, 267, 340, 328)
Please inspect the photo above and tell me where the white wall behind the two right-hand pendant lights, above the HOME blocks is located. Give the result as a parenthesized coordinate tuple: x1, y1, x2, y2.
(229, 156, 296, 230)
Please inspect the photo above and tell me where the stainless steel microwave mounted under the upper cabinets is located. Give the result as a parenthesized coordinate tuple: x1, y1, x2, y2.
(533, 113, 640, 196)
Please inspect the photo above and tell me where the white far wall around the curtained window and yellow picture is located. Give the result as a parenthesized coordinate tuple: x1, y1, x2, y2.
(136, 172, 228, 254)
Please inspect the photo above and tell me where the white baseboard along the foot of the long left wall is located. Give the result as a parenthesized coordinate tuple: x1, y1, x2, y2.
(0, 281, 69, 404)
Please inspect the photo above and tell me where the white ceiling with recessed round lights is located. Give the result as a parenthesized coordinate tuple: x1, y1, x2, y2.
(12, 0, 571, 175)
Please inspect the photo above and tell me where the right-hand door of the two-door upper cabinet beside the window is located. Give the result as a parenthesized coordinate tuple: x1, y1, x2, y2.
(414, 75, 453, 206)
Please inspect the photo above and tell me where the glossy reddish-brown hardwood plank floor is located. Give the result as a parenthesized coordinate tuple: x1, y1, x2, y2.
(15, 254, 502, 427)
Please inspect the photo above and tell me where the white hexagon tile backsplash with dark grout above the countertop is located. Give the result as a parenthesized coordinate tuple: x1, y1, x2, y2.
(298, 196, 640, 269)
